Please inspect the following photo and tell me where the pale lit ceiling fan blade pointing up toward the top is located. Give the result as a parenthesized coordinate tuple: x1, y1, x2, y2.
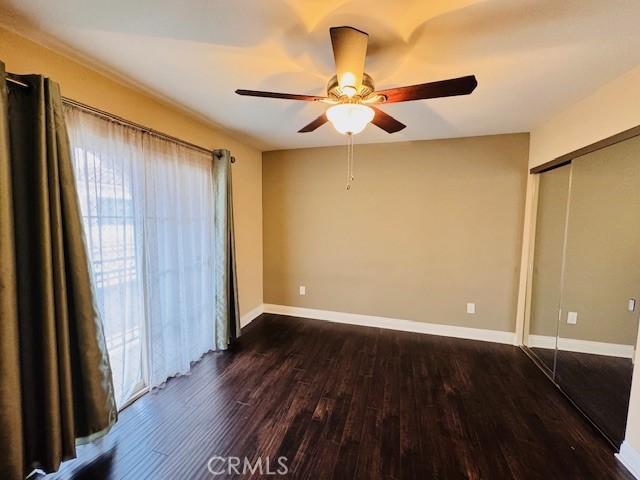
(329, 27, 369, 93)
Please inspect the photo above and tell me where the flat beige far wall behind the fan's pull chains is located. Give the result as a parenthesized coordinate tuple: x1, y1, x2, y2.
(263, 134, 529, 332)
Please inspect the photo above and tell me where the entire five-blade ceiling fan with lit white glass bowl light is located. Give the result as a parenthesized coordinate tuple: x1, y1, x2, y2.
(236, 26, 478, 135)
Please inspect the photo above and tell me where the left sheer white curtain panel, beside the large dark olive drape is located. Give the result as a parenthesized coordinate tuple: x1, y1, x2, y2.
(65, 109, 146, 406)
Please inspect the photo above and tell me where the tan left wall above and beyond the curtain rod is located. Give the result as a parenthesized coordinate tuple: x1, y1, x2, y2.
(0, 28, 262, 314)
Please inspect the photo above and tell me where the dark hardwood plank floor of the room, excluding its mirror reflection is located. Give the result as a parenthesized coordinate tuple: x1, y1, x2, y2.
(42, 315, 632, 480)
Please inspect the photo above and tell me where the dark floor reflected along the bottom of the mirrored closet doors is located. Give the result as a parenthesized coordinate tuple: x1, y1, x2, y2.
(532, 348, 633, 447)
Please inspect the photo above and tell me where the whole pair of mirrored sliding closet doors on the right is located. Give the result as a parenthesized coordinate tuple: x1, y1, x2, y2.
(525, 133, 640, 447)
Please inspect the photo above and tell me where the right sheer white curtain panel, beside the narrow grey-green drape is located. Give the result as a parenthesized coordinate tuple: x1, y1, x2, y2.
(144, 136, 215, 386)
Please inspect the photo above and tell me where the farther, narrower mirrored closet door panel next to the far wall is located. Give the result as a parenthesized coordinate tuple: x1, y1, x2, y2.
(527, 165, 571, 372)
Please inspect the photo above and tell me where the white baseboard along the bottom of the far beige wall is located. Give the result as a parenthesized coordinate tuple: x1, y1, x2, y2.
(264, 304, 515, 345)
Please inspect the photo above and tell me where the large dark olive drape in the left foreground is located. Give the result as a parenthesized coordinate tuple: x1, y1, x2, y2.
(0, 62, 117, 479)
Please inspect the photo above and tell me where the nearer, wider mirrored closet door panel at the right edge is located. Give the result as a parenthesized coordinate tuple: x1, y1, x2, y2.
(555, 137, 640, 446)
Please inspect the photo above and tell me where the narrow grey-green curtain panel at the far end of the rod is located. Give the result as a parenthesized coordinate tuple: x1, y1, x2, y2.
(213, 150, 240, 350)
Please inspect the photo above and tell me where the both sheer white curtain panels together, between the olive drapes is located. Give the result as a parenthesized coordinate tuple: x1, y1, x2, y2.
(65, 107, 215, 406)
